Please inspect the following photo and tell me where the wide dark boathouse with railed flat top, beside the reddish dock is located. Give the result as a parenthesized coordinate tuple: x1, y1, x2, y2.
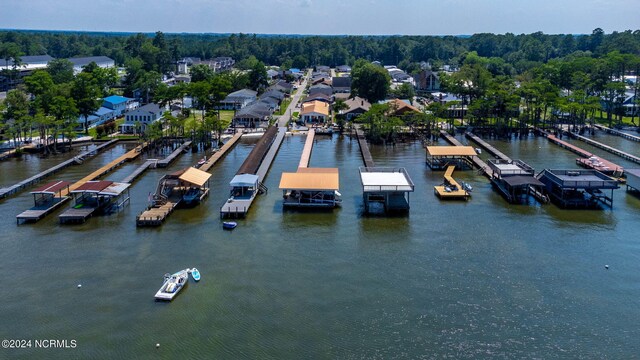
(536, 169, 619, 208)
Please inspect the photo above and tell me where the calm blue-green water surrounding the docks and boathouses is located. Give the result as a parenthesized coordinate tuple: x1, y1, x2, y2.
(0, 135, 640, 359)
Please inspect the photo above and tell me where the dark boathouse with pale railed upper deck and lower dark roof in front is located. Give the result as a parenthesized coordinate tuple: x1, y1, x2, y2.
(488, 159, 548, 204)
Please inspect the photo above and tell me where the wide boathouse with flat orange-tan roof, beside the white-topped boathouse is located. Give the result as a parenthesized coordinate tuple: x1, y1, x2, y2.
(279, 167, 342, 208)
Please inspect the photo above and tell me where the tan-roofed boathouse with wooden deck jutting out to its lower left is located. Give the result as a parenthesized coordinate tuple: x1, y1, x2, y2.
(136, 167, 211, 226)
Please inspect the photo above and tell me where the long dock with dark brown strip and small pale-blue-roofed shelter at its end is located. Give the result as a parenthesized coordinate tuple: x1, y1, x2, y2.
(220, 126, 287, 218)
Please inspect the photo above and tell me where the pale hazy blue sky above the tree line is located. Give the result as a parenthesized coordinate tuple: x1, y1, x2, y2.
(0, 0, 640, 35)
